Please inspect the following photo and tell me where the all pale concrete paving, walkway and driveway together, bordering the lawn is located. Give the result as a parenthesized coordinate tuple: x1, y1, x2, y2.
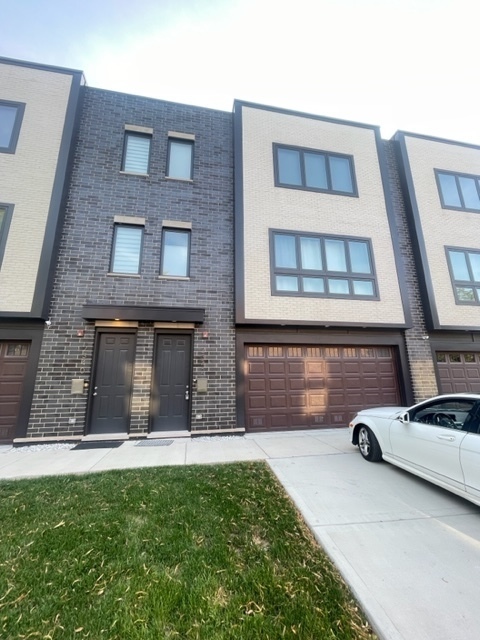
(0, 429, 480, 640)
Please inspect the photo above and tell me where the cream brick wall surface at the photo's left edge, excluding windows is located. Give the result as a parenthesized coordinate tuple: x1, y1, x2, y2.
(0, 64, 72, 312)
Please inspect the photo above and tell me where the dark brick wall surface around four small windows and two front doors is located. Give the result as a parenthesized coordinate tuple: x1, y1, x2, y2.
(28, 88, 236, 438)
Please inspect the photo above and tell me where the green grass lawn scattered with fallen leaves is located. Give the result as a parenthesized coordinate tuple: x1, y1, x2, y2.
(0, 463, 373, 640)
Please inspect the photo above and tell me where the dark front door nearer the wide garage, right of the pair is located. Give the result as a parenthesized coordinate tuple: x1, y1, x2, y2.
(152, 333, 192, 431)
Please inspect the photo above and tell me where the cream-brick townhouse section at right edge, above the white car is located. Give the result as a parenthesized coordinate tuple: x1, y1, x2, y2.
(394, 132, 480, 393)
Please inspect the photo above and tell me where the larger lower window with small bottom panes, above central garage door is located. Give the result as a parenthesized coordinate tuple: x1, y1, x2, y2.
(270, 231, 378, 299)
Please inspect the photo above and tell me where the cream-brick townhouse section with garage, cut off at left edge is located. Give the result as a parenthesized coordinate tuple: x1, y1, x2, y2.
(0, 58, 84, 442)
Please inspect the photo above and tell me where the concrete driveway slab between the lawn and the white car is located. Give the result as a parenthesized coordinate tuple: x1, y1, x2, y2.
(269, 433, 480, 640)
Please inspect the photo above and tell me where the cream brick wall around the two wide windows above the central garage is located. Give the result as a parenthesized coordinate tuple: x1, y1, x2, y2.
(243, 107, 405, 324)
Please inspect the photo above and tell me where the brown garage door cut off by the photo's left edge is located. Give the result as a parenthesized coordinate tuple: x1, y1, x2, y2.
(0, 342, 30, 442)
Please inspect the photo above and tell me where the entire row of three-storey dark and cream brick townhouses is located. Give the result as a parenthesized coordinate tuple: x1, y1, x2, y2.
(0, 59, 480, 442)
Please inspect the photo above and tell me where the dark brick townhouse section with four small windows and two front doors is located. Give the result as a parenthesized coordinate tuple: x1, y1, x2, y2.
(23, 87, 235, 438)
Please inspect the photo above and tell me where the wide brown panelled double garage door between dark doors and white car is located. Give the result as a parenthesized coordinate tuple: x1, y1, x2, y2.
(245, 345, 400, 431)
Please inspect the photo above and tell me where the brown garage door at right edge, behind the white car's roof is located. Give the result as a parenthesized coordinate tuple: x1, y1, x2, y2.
(437, 351, 480, 393)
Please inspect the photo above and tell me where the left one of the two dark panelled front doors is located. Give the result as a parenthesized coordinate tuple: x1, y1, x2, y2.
(89, 332, 136, 434)
